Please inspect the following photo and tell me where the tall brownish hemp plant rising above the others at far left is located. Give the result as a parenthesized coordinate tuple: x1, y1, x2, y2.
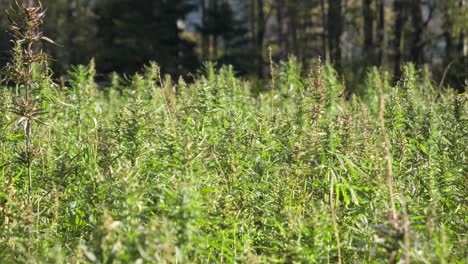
(0, 0, 53, 194)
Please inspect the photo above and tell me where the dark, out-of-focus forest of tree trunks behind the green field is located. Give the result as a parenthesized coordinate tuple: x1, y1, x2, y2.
(0, 0, 468, 90)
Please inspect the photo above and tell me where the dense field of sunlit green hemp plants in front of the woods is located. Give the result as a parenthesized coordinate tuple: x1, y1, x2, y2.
(0, 2, 468, 263)
